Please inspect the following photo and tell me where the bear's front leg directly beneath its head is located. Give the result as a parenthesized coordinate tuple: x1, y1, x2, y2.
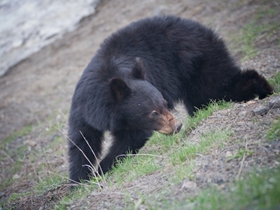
(98, 130, 153, 174)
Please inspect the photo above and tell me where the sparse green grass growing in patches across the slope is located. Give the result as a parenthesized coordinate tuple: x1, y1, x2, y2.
(0, 2, 280, 209)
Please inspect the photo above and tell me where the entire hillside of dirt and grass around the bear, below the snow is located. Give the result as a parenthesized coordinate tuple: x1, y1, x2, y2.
(0, 0, 280, 209)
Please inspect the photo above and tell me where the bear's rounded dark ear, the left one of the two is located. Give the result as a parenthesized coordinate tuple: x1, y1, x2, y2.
(110, 78, 131, 102)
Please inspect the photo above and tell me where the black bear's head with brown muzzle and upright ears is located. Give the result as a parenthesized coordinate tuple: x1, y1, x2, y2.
(110, 58, 182, 135)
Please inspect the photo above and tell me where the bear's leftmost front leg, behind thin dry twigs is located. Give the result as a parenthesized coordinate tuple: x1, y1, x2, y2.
(68, 126, 103, 183)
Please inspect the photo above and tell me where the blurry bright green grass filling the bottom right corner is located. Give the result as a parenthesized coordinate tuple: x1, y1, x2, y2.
(190, 168, 280, 210)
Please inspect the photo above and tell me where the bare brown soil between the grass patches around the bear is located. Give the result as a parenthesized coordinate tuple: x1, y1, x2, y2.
(0, 0, 280, 209)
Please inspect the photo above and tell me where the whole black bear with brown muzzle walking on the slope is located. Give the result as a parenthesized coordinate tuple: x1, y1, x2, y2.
(69, 16, 273, 182)
